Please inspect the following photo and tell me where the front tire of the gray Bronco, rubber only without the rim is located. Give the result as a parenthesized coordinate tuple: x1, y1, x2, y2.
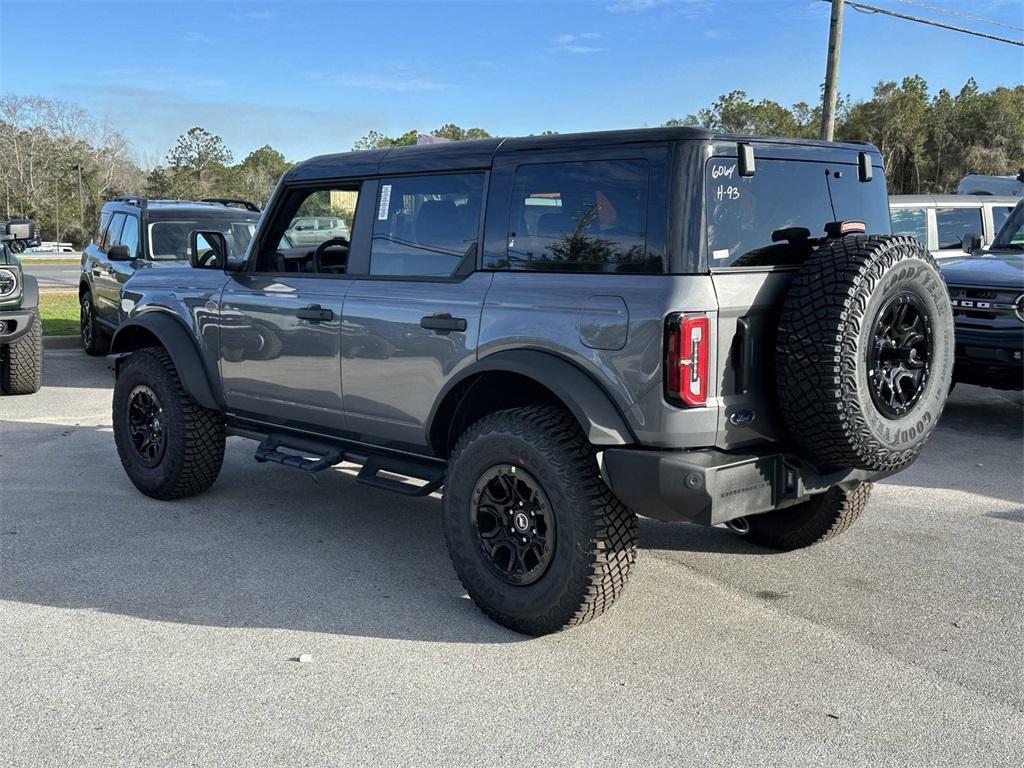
(113, 347, 225, 500)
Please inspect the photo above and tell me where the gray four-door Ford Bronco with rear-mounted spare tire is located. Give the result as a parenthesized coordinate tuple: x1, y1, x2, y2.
(111, 128, 953, 634)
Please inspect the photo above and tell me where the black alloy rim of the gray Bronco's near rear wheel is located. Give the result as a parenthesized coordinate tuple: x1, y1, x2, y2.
(470, 465, 555, 586)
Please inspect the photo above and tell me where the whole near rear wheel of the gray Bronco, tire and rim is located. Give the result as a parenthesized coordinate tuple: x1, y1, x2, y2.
(442, 407, 637, 635)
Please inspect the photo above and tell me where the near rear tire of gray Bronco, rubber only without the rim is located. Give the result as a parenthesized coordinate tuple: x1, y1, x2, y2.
(442, 407, 637, 635)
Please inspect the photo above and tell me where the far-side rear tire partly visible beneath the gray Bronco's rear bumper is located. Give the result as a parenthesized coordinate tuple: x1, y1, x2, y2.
(743, 482, 871, 550)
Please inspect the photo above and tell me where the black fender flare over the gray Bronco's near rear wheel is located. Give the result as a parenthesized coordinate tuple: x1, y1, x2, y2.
(427, 349, 637, 445)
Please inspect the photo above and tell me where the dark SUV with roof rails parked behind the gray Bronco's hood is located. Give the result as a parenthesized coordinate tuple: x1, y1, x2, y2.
(78, 197, 260, 354)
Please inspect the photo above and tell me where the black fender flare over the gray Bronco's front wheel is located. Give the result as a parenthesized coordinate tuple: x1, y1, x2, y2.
(111, 311, 224, 411)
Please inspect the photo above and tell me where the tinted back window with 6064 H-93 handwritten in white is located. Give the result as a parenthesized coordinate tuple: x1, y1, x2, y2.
(705, 158, 890, 268)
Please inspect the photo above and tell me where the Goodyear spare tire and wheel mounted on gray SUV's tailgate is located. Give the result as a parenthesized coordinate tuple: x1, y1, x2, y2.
(775, 236, 954, 471)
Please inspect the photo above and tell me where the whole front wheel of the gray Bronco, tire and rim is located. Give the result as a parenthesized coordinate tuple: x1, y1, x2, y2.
(114, 347, 224, 499)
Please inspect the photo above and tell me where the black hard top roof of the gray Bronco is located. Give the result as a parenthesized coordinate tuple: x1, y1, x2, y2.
(286, 126, 881, 181)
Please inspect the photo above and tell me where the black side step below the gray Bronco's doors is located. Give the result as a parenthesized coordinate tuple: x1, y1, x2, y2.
(255, 434, 444, 496)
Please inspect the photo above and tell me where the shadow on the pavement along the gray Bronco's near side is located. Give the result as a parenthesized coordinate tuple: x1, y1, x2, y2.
(0, 421, 528, 643)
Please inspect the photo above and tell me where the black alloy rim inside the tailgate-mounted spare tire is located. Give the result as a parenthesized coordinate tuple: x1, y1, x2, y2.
(867, 291, 932, 419)
